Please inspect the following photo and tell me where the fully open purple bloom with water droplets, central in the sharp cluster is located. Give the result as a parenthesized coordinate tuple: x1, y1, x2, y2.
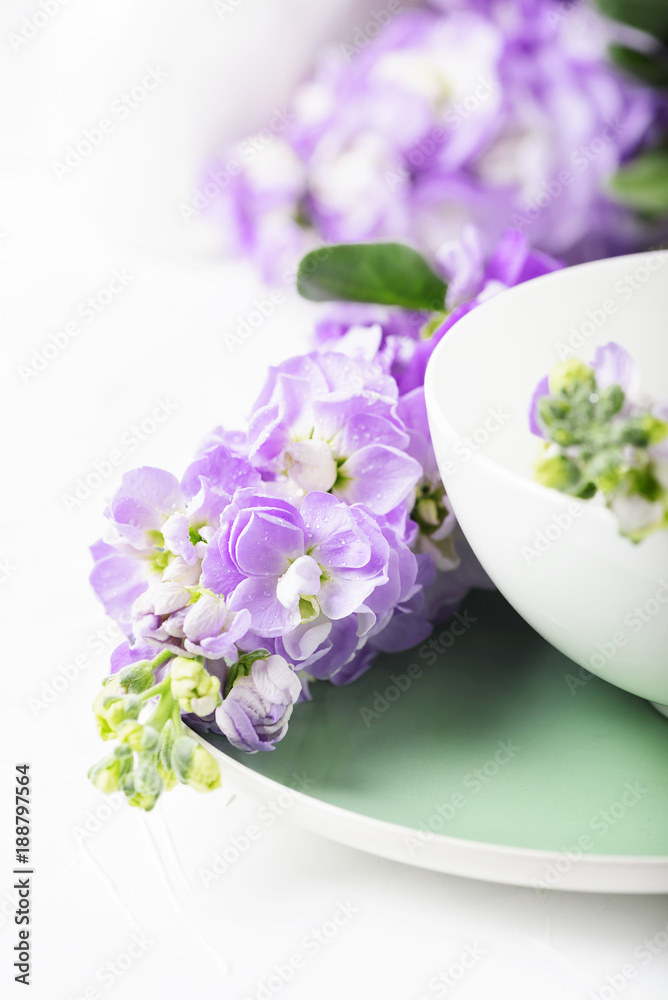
(202, 488, 389, 637)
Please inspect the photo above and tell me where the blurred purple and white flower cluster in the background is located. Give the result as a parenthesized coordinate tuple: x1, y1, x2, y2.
(205, 0, 666, 280)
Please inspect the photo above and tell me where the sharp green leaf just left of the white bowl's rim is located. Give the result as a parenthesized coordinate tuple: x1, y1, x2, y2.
(297, 243, 447, 312)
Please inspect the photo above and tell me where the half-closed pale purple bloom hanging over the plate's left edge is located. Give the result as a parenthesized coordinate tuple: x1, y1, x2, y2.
(216, 655, 302, 753)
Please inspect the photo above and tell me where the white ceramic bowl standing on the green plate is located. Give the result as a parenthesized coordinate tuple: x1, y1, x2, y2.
(425, 251, 668, 705)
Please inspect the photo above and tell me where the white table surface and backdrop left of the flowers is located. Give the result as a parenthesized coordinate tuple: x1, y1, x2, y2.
(0, 0, 668, 1000)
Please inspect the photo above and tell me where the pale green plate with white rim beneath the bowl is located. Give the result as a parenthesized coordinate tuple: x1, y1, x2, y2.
(201, 591, 668, 892)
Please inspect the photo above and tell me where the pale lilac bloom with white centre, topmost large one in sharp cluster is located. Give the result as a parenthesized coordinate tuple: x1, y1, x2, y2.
(248, 353, 421, 514)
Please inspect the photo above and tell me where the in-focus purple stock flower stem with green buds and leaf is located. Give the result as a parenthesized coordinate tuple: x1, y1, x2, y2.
(91, 233, 558, 809)
